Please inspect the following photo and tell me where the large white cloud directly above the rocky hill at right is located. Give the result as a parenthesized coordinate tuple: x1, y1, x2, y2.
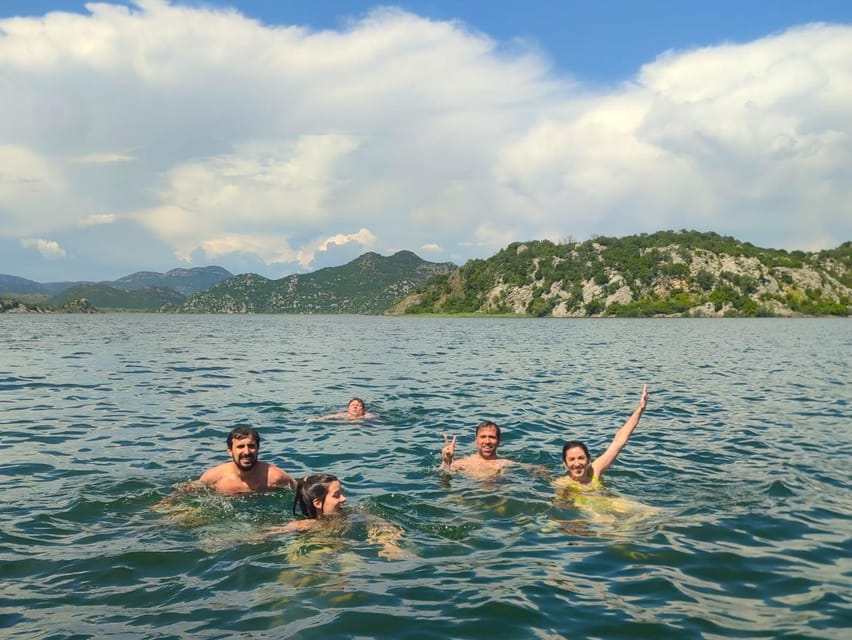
(498, 26, 852, 248)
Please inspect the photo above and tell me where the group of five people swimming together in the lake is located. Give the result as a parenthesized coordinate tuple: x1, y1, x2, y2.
(198, 385, 648, 533)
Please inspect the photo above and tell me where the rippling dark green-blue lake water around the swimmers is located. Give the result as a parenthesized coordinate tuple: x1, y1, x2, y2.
(0, 314, 852, 639)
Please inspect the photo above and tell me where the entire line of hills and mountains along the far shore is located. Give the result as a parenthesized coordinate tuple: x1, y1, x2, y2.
(0, 230, 852, 318)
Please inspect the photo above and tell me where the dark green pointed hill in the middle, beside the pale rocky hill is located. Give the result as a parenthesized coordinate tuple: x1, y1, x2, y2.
(175, 251, 456, 314)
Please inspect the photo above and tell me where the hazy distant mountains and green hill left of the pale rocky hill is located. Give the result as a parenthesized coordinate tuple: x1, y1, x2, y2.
(0, 251, 456, 314)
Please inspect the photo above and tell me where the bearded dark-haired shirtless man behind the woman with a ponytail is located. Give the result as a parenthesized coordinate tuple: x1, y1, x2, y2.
(198, 427, 296, 493)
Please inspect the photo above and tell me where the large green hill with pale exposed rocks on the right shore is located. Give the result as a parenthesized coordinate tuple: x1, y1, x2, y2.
(390, 231, 852, 317)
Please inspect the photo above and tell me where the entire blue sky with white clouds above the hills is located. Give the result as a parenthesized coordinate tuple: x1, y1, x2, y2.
(0, 0, 852, 282)
